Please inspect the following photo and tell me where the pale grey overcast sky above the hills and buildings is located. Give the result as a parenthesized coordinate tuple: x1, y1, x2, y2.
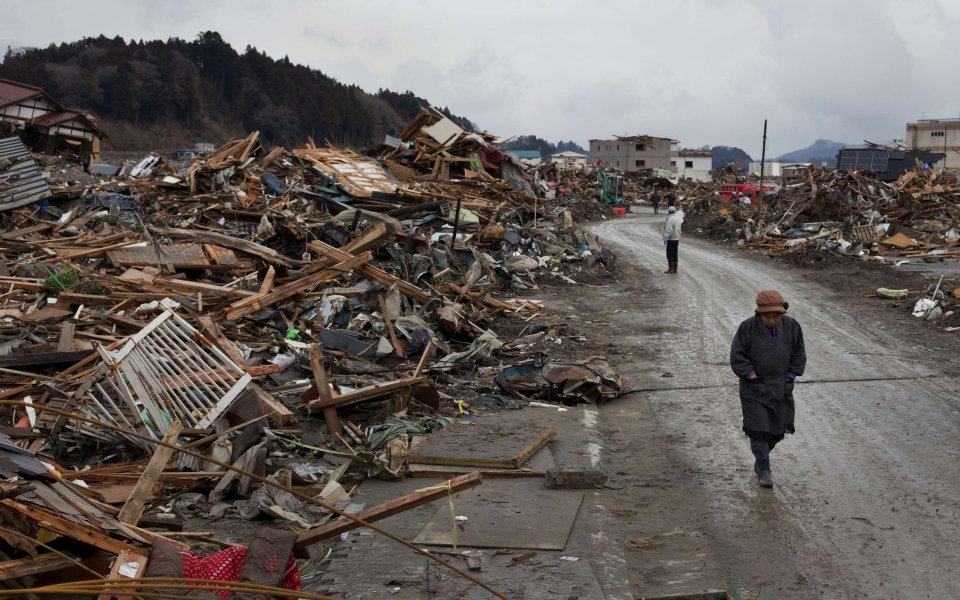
(0, 0, 960, 158)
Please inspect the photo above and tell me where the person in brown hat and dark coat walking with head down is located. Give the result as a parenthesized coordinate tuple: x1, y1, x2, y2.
(730, 290, 807, 487)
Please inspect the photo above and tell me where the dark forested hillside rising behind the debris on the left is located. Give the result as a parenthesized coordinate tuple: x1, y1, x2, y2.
(0, 31, 473, 149)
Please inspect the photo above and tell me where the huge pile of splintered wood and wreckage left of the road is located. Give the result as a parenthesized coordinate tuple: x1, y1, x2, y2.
(0, 109, 629, 594)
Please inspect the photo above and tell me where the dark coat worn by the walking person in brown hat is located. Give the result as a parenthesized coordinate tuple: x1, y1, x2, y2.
(730, 315, 807, 441)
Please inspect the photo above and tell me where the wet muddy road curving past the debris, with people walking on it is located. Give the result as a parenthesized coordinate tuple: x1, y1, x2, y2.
(549, 209, 960, 600)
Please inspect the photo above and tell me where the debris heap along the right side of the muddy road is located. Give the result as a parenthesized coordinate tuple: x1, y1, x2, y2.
(678, 166, 960, 330)
